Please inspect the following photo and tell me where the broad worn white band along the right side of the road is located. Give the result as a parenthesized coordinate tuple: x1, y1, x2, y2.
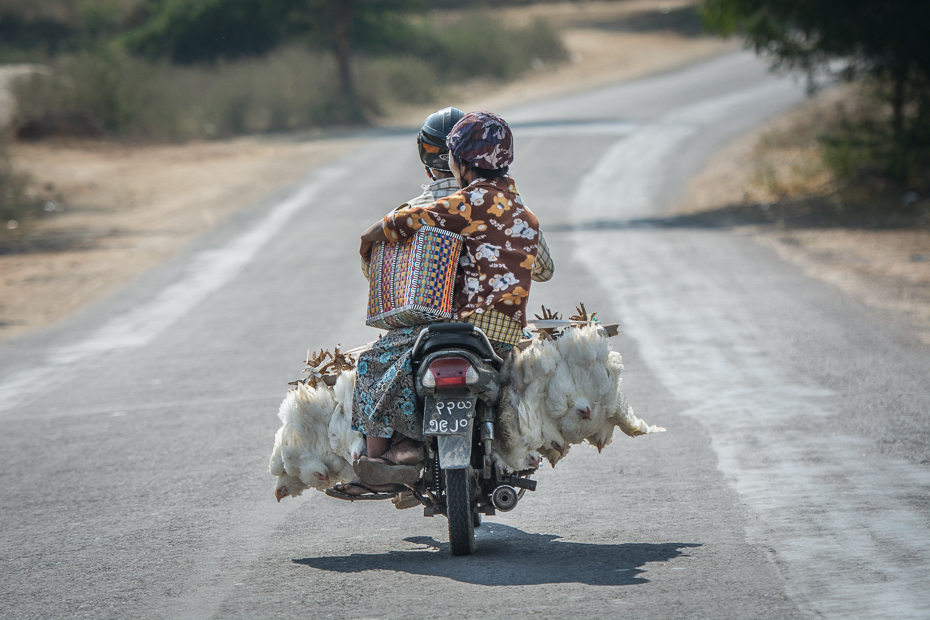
(573, 89, 930, 618)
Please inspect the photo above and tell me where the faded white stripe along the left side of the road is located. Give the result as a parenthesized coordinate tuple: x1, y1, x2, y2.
(0, 166, 349, 411)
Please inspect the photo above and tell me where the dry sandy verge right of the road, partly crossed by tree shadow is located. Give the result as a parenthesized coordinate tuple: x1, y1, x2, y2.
(679, 87, 930, 344)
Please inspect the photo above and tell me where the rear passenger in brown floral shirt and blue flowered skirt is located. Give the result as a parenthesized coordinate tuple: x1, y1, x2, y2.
(334, 110, 552, 498)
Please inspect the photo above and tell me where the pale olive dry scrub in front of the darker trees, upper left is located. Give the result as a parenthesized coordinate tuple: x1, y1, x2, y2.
(7, 14, 565, 142)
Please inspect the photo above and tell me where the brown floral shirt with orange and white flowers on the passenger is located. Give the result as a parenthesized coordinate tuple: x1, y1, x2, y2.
(382, 177, 539, 326)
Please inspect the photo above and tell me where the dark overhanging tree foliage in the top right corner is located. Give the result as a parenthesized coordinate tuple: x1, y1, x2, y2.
(702, 0, 930, 182)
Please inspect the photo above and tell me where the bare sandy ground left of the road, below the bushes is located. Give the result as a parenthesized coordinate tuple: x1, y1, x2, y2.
(0, 138, 356, 338)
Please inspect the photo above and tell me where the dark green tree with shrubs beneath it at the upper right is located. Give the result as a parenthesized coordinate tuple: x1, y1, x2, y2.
(702, 0, 930, 190)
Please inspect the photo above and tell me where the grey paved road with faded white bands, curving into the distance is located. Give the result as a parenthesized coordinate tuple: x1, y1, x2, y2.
(0, 54, 930, 618)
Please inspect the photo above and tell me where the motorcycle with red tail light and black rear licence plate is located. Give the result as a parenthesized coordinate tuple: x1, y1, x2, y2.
(410, 323, 536, 555)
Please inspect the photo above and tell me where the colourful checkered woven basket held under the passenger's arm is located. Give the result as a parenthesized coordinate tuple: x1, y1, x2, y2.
(365, 226, 462, 329)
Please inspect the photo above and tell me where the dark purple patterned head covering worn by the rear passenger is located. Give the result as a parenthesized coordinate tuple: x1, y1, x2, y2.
(446, 111, 513, 170)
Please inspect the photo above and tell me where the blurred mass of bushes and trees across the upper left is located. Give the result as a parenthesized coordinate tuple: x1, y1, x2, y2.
(0, 0, 565, 141)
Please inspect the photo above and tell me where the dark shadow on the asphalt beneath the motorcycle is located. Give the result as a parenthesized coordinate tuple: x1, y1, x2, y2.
(293, 523, 700, 586)
